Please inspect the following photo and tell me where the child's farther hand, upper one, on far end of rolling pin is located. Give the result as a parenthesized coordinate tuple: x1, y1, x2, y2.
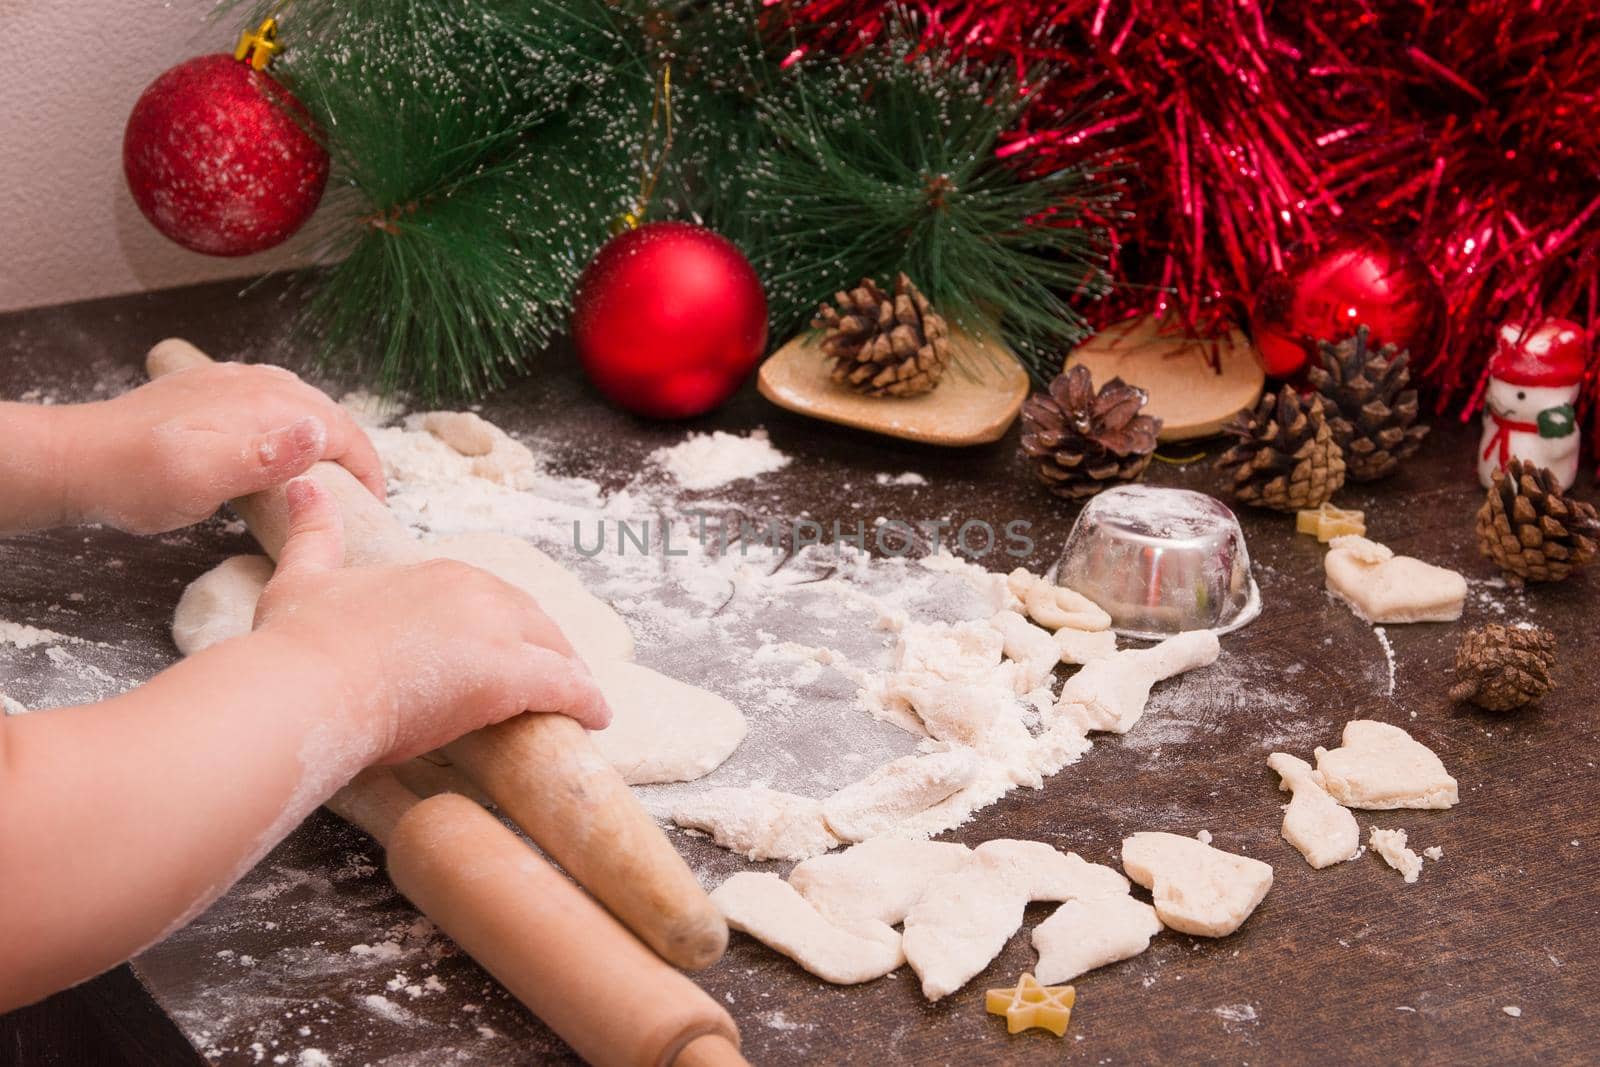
(72, 363, 384, 533)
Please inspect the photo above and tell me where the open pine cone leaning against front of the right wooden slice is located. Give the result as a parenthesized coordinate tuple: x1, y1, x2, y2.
(1022, 365, 1162, 501)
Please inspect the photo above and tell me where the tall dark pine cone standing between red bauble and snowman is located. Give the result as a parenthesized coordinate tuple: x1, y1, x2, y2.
(1307, 326, 1427, 482)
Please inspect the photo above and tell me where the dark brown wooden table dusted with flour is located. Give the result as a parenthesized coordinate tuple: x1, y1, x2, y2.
(0, 283, 1600, 1064)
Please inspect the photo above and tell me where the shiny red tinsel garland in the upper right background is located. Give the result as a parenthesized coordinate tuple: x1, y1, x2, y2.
(771, 0, 1600, 445)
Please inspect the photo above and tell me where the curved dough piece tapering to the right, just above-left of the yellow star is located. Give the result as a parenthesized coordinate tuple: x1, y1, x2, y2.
(904, 838, 1128, 1000)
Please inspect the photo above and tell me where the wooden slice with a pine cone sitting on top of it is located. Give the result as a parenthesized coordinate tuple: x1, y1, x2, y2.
(755, 331, 1029, 448)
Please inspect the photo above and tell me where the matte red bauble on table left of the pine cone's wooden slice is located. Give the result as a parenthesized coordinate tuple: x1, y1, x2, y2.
(573, 222, 766, 419)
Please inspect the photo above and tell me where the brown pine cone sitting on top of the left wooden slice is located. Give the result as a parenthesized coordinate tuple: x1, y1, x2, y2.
(811, 274, 950, 397)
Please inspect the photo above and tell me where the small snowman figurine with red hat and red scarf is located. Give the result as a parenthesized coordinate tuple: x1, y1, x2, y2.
(1478, 318, 1587, 490)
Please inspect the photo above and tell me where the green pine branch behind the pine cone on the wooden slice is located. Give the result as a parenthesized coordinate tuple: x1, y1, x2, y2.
(659, 0, 1118, 384)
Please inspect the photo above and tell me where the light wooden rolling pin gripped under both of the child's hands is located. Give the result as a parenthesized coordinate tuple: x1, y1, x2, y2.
(146, 338, 728, 969)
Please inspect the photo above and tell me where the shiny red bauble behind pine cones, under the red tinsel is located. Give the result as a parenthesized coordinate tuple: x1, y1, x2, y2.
(1250, 234, 1445, 378)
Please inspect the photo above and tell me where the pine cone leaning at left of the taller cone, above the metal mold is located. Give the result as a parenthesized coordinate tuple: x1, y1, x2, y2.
(1216, 386, 1344, 512)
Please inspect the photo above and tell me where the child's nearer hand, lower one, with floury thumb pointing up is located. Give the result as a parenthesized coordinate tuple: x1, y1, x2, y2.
(256, 478, 611, 761)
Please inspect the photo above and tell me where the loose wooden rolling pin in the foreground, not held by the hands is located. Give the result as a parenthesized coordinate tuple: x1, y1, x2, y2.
(328, 768, 746, 1067)
